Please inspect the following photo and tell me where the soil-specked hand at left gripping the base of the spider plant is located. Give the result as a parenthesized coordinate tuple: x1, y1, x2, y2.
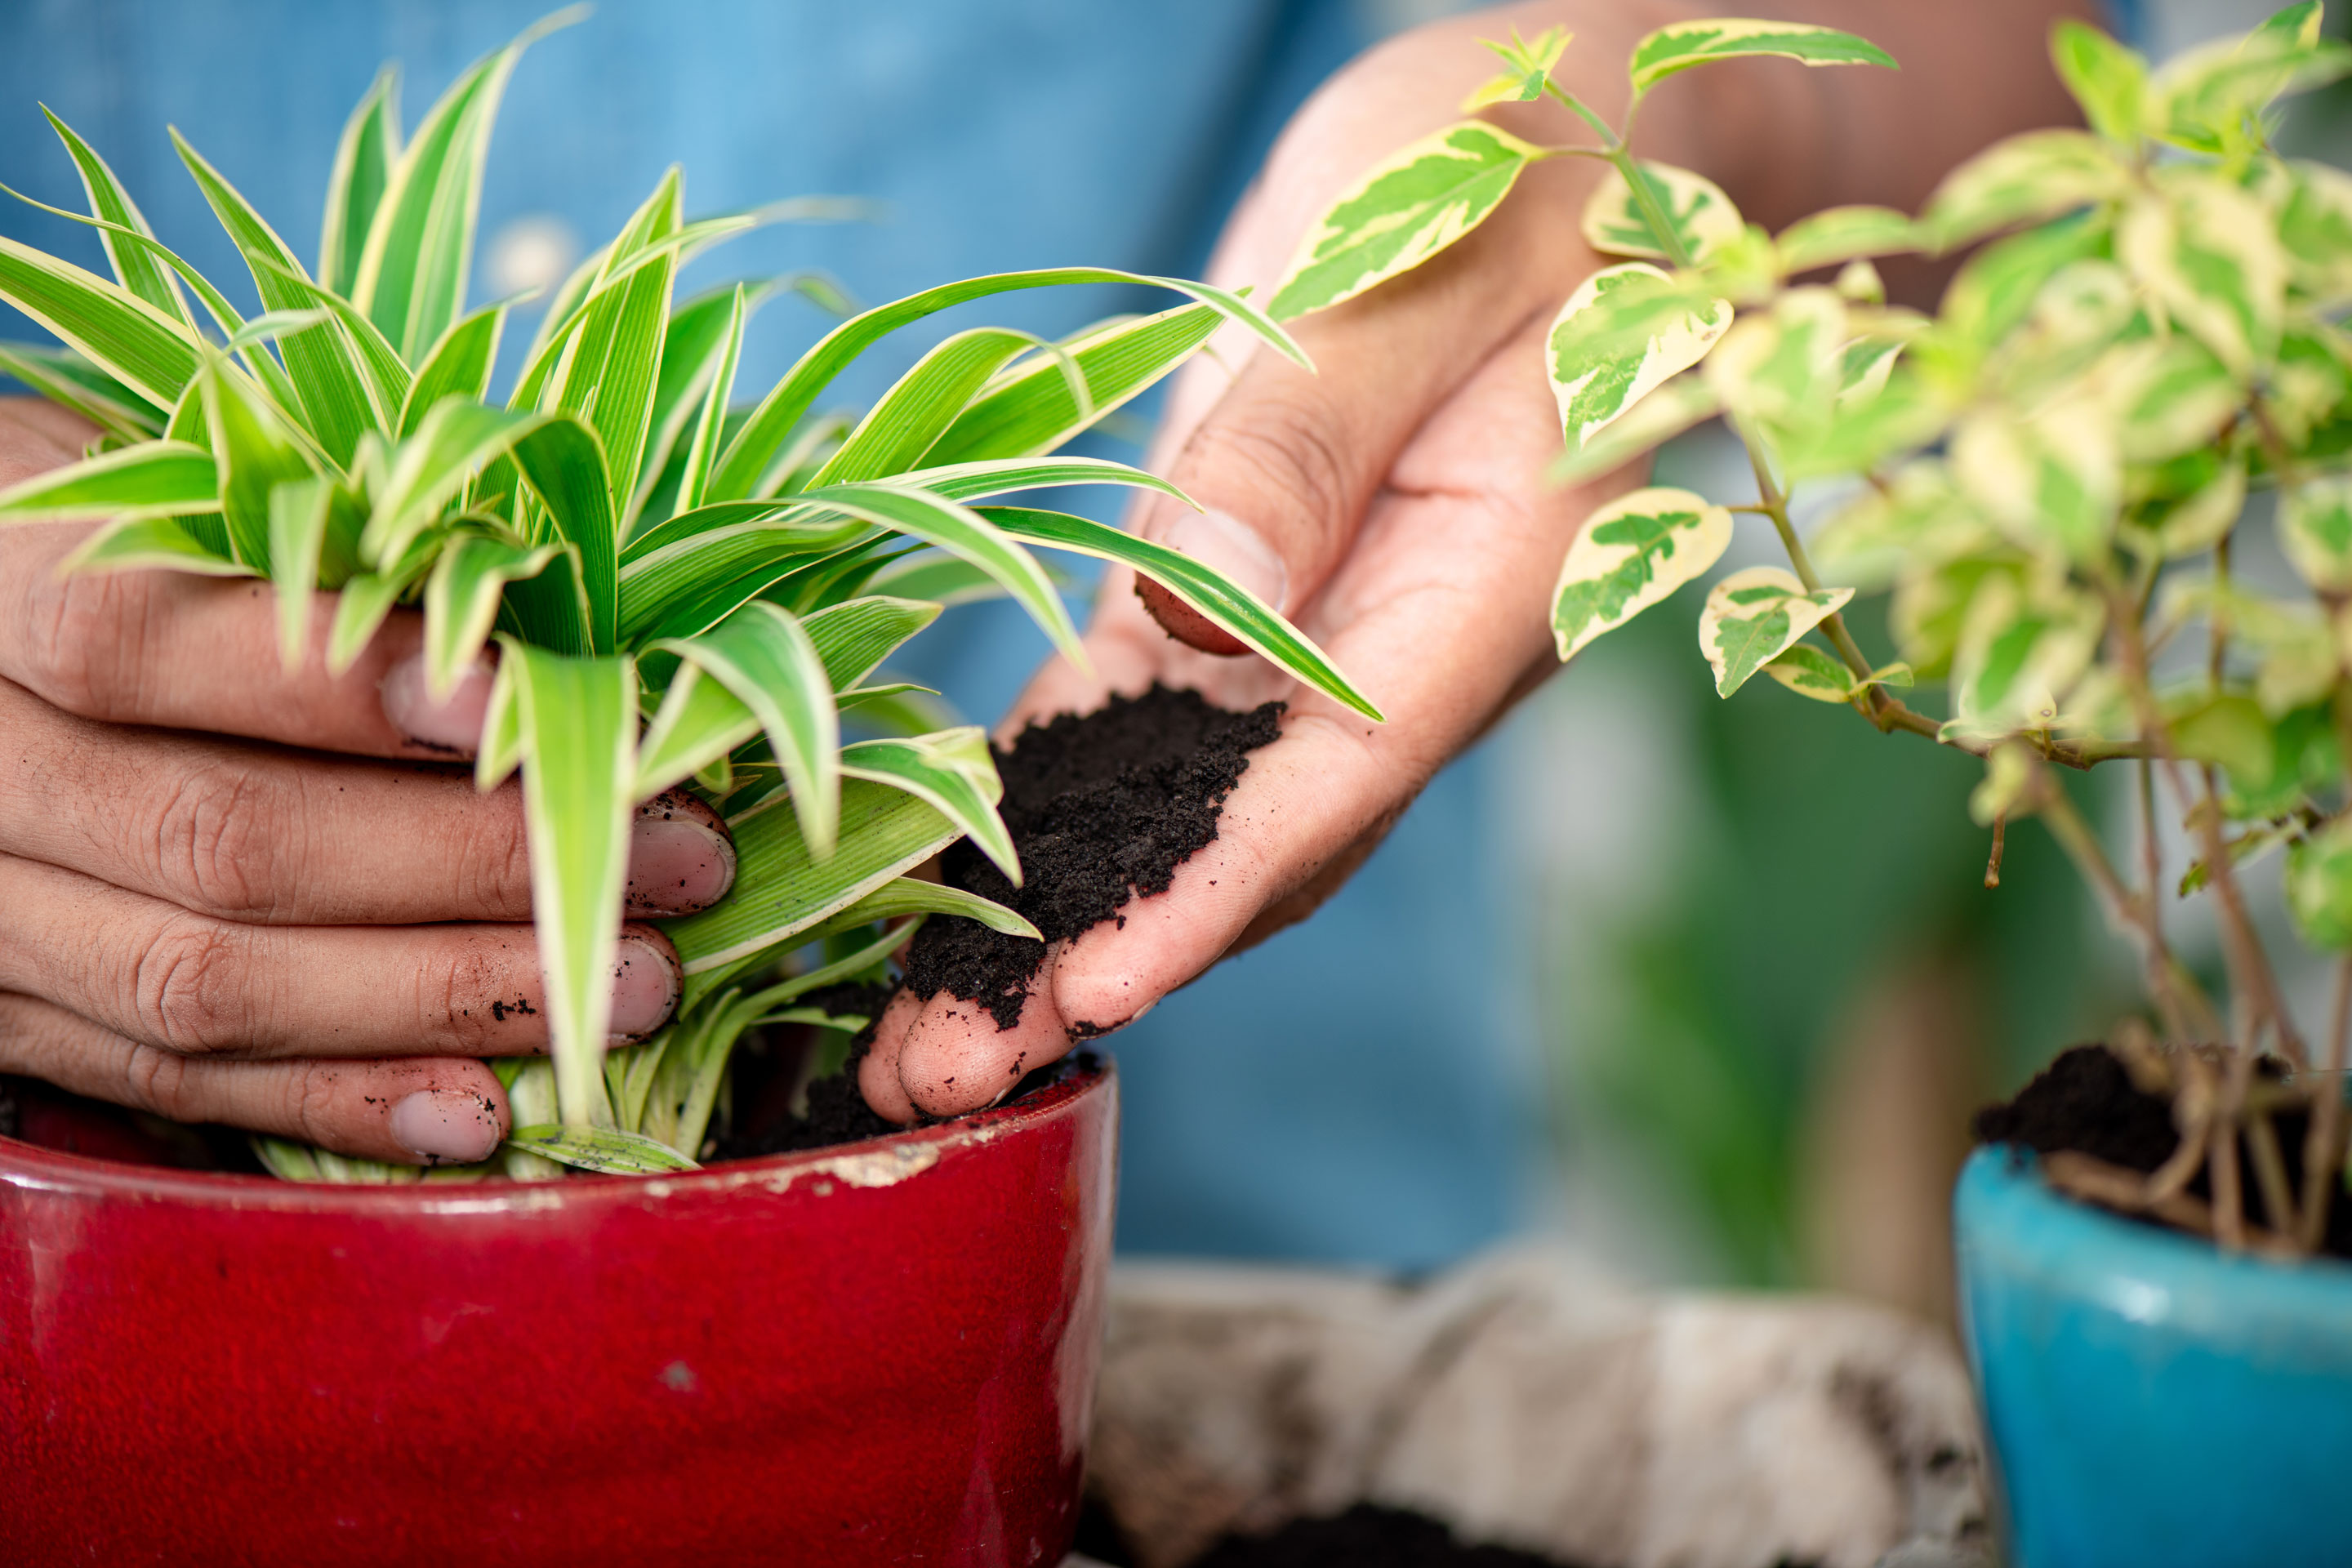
(0, 397, 734, 1164)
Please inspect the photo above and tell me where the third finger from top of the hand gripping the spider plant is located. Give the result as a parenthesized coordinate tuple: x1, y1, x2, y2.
(0, 856, 679, 1058)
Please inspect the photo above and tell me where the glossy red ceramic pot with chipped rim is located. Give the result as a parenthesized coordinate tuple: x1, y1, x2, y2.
(0, 1067, 1117, 1568)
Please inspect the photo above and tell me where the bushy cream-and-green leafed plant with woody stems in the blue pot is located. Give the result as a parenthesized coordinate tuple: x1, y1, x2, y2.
(1272, 0, 2352, 1250)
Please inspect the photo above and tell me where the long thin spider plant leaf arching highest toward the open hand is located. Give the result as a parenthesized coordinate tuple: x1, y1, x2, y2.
(706, 268, 1307, 501)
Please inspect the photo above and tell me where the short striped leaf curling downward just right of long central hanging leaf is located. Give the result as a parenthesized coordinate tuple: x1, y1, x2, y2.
(652, 599, 842, 861)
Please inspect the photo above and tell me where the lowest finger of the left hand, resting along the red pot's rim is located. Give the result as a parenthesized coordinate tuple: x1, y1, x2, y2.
(0, 992, 510, 1166)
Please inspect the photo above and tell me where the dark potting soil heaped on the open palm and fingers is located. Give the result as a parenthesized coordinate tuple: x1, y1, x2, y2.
(906, 687, 1282, 1030)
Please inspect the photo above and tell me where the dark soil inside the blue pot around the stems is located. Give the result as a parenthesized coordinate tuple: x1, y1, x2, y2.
(1976, 1046, 2352, 1258)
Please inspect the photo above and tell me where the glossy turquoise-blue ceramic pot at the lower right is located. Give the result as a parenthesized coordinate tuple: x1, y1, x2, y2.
(1954, 1147, 2352, 1568)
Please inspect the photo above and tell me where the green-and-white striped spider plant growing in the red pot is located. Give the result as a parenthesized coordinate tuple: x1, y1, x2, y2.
(0, 14, 1379, 1180)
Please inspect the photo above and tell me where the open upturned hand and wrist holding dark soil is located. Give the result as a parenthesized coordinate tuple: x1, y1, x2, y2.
(861, 0, 2077, 1121)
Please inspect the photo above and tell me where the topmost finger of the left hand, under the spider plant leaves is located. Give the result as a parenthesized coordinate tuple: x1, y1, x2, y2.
(0, 522, 492, 757)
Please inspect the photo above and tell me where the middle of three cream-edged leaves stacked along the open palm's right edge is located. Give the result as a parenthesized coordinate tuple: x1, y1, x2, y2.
(1548, 261, 1731, 454)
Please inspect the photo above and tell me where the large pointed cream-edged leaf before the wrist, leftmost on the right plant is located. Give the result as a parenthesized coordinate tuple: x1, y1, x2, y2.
(1267, 120, 1545, 322)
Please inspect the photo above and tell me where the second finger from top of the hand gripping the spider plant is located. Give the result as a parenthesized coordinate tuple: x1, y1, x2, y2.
(0, 682, 734, 924)
